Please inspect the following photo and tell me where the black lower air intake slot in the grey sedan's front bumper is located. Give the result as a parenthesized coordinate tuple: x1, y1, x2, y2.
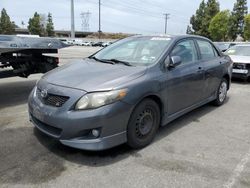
(30, 114, 62, 138)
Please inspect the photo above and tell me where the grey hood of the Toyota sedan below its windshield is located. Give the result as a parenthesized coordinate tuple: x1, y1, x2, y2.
(42, 59, 147, 92)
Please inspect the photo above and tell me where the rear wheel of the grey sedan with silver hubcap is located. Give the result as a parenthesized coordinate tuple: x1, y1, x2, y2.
(213, 78, 228, 106)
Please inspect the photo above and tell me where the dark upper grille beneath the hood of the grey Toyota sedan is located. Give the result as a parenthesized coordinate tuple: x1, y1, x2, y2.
(36, 88, 69, 107)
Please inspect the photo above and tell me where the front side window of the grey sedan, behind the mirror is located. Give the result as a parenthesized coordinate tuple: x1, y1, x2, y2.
(170, 40, 198, 64)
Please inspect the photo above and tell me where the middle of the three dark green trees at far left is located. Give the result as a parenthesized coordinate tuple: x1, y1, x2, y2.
(28, 12, 42, 35)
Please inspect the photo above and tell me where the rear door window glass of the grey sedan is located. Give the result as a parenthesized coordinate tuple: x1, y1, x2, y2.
(197, 40, 218, 60)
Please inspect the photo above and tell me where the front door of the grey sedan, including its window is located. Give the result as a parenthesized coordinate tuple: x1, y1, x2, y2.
(167, 39, 204, 116)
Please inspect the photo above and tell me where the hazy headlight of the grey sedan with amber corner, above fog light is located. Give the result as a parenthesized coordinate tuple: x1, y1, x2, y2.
(75, 89, 127, 110)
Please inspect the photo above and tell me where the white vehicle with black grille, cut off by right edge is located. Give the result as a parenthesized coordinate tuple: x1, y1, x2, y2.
(225, 44, 250, 81)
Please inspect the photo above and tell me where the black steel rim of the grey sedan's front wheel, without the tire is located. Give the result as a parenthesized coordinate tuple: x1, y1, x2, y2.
(136, 109, 154, 138)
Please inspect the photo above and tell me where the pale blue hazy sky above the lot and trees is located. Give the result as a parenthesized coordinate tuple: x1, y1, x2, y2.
(0, 0, 250, 34)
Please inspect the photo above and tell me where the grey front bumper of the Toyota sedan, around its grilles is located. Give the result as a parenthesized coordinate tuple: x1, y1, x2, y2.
(28, 83, 133, 150)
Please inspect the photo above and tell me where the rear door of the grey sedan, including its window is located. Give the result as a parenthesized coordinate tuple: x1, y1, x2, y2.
(196, 39, 223, 99)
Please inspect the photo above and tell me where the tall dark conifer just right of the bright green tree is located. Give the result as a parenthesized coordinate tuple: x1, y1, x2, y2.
(229, 0, 248, 40)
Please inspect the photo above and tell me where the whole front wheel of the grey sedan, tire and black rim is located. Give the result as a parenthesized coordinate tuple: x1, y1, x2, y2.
(127, 99, 160, 149)
